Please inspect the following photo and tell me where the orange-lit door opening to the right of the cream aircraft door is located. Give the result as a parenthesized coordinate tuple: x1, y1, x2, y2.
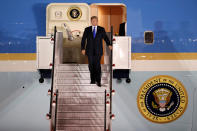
(91, 3, 127, 64)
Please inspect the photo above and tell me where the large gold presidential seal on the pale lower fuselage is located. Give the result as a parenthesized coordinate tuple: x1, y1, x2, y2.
(137, 75, 188, 123)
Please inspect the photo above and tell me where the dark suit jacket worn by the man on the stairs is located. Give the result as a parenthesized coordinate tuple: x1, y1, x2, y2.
(81, 26, 111, 56)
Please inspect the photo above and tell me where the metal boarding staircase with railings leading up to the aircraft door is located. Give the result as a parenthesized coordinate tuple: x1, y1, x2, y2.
(47, 28, 113, 131)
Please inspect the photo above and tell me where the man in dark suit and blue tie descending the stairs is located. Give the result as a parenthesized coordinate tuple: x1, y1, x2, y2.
(81, 16, 112, 87)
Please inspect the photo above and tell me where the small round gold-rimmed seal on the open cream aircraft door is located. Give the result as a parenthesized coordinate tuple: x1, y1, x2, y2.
(67, 7, 82, 21)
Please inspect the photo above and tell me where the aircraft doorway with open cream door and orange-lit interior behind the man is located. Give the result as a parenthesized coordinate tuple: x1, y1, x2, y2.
(46, 3, 127, 64)
